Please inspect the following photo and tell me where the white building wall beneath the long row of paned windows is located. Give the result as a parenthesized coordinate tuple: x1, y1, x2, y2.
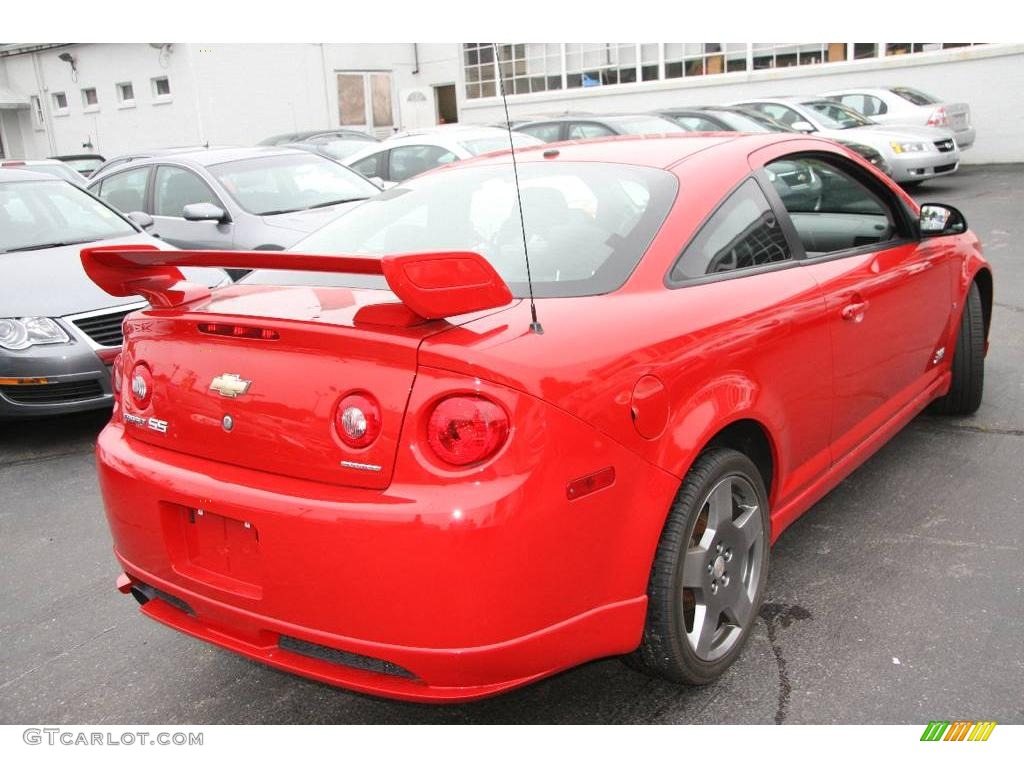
(459, 44, 1024, 163)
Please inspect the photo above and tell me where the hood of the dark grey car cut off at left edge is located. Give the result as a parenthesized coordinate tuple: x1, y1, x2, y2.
(0, 232, 224, 317)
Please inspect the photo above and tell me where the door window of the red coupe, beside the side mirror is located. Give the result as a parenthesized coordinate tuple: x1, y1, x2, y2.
(765, 158, 897, 257)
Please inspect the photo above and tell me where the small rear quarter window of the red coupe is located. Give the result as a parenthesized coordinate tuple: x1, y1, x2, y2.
(670, 179, 793, 282)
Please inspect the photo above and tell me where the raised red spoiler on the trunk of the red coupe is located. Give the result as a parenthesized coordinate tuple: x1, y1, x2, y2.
(82, 245, 512, 319)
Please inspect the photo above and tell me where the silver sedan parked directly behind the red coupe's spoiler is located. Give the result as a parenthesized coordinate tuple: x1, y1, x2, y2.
(89, 146, 380, 250)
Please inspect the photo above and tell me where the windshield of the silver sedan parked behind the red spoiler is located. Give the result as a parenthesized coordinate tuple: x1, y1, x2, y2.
(209, 153, 380, 216)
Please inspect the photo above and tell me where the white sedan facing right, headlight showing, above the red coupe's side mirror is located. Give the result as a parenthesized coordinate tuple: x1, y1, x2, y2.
(738, 96, 959, 185)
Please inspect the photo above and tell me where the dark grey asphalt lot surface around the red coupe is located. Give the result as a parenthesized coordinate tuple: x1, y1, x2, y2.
(0, 166, 1024, 723)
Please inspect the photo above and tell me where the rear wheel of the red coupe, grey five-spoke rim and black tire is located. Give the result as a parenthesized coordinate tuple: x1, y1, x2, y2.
(625, 449, 770, 685)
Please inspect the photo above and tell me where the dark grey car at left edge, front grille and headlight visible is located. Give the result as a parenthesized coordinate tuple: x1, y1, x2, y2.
(0, 169, 228, 421)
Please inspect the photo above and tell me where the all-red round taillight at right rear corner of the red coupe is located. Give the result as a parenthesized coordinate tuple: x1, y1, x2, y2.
(427, 395, 509, 467)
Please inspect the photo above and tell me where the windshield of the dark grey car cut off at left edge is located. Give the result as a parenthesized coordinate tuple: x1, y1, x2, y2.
(0, 180, 135, 253)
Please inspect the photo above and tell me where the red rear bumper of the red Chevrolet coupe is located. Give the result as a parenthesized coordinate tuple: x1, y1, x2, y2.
(96, 415, 679, 701)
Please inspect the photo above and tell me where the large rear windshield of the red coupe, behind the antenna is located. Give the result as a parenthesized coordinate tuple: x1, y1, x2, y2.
(244, 162, 678, 297)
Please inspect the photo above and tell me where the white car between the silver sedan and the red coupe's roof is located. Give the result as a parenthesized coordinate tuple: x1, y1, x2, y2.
(345, 125, 541, 186)
